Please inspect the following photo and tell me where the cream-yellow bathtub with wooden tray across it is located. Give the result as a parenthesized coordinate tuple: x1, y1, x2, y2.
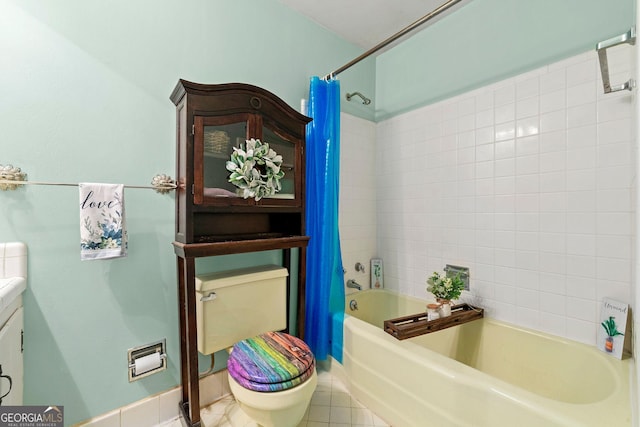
(341, 290, 632, 427)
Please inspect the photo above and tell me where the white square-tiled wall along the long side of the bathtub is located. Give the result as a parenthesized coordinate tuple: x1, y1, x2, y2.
(372, 48, 636, 344)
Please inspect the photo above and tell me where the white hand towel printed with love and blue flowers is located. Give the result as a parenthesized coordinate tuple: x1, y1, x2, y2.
(78, 183, 127, 261)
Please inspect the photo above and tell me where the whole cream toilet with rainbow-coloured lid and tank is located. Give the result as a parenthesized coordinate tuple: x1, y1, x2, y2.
(196, 265, 318, 427)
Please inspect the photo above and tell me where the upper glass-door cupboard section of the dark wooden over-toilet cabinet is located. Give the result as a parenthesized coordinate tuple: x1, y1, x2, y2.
(171, 80, 310, 243)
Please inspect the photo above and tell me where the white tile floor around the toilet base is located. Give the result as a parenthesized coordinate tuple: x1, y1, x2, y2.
(162, 370, 389, 427)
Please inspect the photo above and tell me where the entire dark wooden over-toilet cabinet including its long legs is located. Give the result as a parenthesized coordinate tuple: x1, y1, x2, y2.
(171, 80, 311, 427)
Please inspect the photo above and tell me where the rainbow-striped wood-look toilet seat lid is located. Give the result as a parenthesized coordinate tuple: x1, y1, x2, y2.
(227, 332, 315, 392)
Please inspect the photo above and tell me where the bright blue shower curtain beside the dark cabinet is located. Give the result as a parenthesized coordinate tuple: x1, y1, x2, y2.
(304, 77, 344, 362)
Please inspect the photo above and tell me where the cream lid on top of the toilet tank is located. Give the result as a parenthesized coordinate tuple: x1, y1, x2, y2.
(196, 265, 289, 292)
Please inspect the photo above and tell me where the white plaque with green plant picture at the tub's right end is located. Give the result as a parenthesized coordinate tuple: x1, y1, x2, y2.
(596, 298, 629, 359)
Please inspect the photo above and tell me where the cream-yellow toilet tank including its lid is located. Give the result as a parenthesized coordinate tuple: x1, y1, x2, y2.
(196, 265, 288, 354)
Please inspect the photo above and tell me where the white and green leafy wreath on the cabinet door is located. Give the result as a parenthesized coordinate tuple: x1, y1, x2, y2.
(227, 138, 284, 201)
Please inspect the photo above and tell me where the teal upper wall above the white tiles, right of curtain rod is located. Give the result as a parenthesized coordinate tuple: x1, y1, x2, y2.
(375, 0, 635, 120)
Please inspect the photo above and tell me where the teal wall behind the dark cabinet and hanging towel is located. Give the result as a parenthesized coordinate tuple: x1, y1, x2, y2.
(0, 0, 374, 424)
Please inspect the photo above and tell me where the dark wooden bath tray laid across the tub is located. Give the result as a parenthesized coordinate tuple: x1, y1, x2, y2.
(384, 303, 484, 340)
